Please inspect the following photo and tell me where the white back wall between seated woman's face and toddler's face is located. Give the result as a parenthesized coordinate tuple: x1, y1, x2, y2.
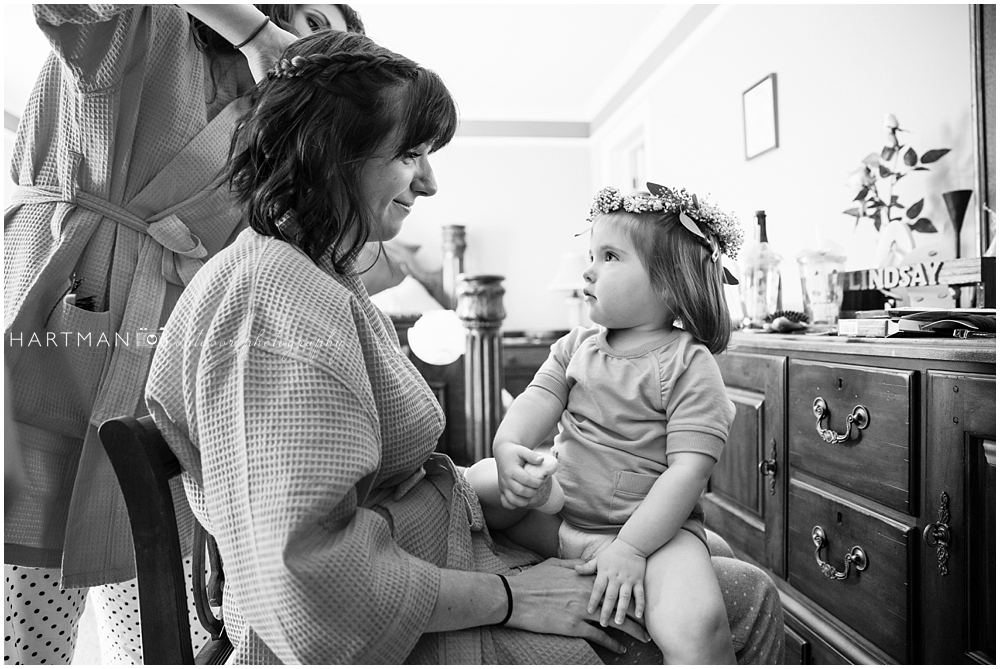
(400, 137, 592, 330)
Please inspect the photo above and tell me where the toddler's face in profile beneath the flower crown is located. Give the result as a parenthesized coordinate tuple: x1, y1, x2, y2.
(583, 216, 669, 331)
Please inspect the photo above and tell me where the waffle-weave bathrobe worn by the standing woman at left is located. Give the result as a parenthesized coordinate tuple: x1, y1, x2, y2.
(4, 5, 253, 588)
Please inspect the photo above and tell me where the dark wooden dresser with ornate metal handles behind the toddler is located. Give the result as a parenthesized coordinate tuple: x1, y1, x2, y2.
(705, 333, 996, 664)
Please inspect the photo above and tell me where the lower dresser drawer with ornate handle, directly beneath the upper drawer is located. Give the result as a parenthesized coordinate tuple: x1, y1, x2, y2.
(788, 478, 915, 663)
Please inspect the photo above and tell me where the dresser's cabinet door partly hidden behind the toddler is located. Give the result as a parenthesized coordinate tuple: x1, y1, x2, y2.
(704, 350, 788, 577)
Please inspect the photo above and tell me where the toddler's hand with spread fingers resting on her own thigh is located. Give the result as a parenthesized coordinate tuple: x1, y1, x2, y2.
(576, 539, 646, 627)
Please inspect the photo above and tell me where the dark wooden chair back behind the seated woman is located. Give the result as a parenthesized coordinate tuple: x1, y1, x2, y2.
(98, 416, 232, 664)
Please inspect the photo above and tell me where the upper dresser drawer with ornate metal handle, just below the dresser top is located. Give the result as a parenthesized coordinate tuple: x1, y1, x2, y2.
(788, 360, 917, 515)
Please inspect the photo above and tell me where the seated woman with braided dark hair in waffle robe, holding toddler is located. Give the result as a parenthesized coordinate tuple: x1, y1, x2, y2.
(146, 33, 782, 664)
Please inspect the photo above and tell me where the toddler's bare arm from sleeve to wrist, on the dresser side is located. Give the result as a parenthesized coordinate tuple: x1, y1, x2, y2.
(618, 452, 715, 557)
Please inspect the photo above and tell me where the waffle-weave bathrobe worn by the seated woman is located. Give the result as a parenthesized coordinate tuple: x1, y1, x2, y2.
(147, 230, 597, 664)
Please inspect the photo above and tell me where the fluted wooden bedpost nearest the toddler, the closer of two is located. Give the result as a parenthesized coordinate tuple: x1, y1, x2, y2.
(455, 275, 507, 463)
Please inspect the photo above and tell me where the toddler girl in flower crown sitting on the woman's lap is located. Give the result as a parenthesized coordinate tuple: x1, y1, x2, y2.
(466, 184, 742, 664)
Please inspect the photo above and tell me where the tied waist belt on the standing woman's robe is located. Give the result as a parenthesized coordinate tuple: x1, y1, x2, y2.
(11, 186, 208, 426)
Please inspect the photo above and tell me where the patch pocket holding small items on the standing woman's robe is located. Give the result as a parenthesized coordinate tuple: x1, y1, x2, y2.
(11, 295, 115, 439)
